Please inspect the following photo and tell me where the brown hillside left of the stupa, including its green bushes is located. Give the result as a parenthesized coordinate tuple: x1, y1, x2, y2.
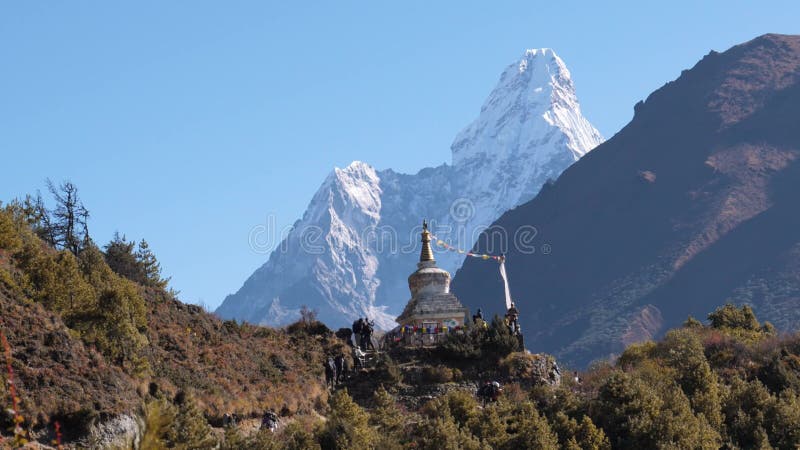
(0, 203, 332, 447)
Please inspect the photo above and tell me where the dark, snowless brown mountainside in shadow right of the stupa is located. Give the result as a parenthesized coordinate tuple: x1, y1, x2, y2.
(454, 34, 800, 365)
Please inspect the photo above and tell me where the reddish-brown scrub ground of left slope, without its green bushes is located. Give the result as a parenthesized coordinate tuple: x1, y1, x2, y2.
(0, 210, 330, 438)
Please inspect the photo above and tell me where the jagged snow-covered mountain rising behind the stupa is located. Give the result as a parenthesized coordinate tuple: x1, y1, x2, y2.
(217, 49, 603, 329)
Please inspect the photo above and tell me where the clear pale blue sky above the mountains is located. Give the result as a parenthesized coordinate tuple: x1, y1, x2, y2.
(0, 0, 800, 306)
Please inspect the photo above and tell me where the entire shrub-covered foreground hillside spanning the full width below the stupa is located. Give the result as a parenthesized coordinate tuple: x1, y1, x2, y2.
(0, 189, 800, 450)
